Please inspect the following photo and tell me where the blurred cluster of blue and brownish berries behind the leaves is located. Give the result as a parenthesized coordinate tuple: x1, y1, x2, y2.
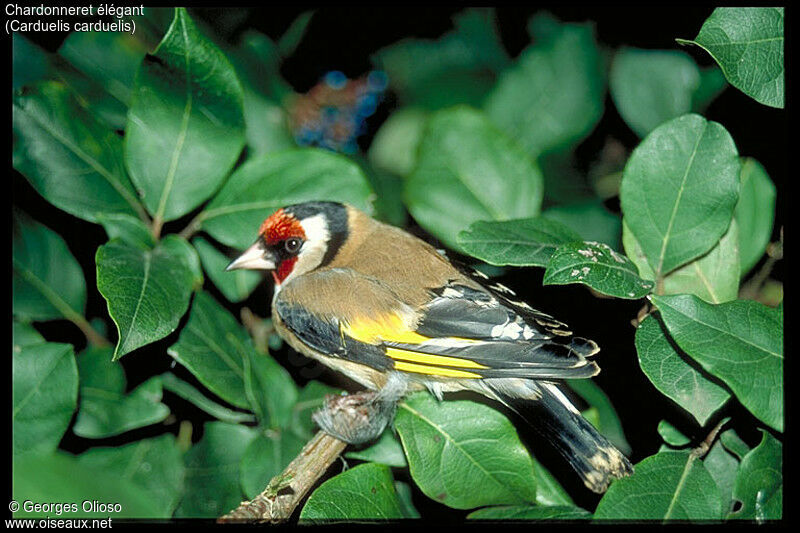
(289, 70, 387, 154)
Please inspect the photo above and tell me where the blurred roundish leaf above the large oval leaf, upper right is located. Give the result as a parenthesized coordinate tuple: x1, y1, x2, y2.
(609, 47, 720, 137)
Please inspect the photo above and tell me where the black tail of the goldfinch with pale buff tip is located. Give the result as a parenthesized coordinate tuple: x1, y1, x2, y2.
(482, 379, 633, 493)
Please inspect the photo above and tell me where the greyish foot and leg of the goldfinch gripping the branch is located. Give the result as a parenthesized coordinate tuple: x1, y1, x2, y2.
(311, 373, 406, 444)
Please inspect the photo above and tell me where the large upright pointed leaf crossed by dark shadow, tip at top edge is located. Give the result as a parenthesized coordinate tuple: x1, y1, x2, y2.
(125, 8, 245, 222)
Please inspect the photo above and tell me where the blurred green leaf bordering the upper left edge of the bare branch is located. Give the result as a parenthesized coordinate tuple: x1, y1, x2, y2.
(239, 431, 306, 498)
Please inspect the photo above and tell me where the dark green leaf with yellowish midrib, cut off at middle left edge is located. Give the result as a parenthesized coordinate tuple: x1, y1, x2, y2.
(11, 209, 86, 320)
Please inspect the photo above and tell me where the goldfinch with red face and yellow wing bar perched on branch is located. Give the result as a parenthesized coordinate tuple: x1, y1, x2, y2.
(227, 201, 633, 493)
